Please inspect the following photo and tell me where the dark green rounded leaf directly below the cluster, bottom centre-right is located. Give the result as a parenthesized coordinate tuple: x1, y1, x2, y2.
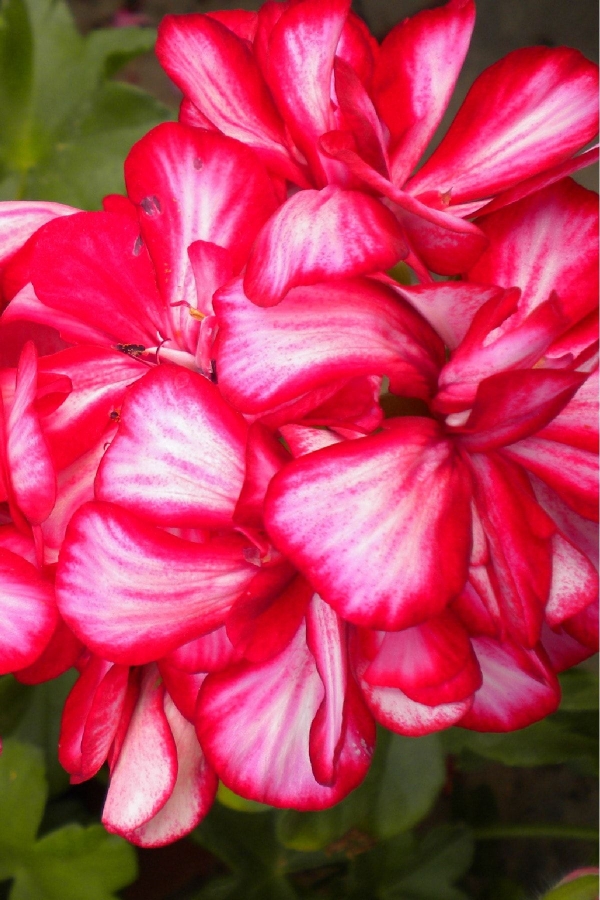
(278, 730, 445, 855)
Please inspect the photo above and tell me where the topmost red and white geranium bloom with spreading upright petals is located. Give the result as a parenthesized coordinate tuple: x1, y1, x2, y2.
(157, 0, 597, 275)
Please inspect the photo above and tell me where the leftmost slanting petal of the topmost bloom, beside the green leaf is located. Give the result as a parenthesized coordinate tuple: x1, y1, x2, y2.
(156, 14, 304, 180)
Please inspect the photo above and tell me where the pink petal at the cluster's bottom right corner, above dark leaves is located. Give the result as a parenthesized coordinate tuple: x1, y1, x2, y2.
(459, 637, 560, 732)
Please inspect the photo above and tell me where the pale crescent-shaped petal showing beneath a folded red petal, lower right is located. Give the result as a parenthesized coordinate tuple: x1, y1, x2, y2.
(353, 633, 473, 737)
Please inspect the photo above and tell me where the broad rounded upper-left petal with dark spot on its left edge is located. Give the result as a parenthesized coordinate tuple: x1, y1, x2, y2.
(125, 122, 279, 317)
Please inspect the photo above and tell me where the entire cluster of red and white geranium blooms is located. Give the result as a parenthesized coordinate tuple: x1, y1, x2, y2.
(0, 0, 598, 846)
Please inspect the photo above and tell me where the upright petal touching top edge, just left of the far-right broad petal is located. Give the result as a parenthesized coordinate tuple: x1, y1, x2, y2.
(372, 0, 475, 187)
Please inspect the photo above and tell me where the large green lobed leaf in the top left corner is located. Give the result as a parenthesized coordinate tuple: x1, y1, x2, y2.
(0, 0, 172, 208)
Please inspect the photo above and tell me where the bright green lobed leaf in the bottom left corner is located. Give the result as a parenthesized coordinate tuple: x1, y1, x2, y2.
(0, 739, 136, 900)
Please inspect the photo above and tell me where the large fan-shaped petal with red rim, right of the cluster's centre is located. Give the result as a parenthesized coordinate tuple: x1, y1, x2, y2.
(265, 417, 471, 630)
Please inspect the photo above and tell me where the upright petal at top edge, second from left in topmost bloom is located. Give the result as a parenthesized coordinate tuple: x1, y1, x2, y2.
(268, 0, 350, 185)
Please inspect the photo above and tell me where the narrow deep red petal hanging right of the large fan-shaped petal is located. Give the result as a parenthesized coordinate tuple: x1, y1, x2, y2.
(469, 453, 555, 647)
